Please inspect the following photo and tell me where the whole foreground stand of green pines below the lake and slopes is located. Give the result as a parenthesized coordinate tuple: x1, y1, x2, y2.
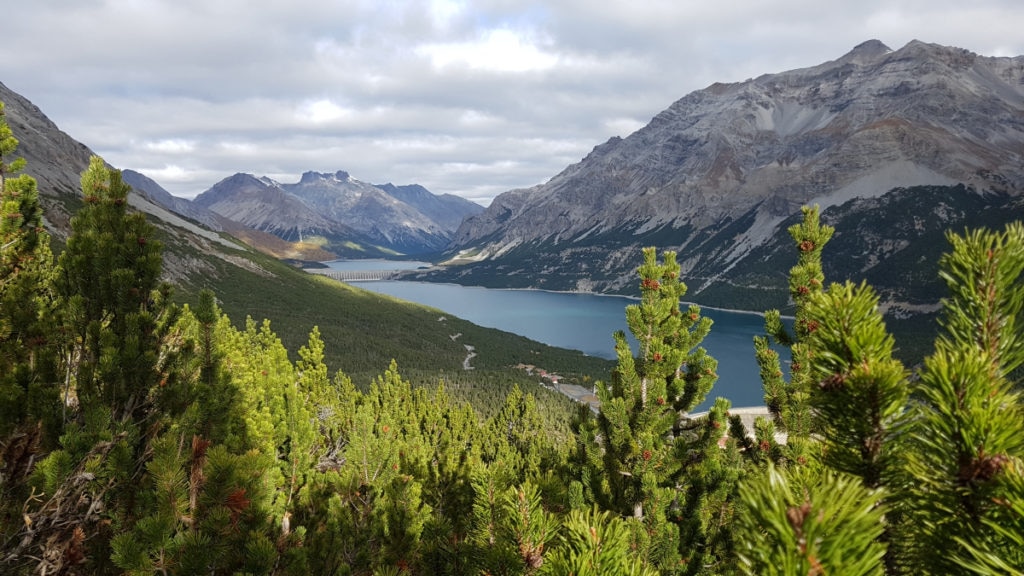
(6, 103, 1024, 576)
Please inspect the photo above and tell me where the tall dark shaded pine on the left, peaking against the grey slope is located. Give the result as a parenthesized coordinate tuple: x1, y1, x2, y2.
(4, 158, 183, 573)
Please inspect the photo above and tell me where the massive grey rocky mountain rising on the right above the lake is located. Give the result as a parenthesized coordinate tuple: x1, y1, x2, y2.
(424, 40, 1024, 311)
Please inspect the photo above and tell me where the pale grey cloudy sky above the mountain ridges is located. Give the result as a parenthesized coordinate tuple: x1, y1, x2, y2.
(0, 0, 1024, 204)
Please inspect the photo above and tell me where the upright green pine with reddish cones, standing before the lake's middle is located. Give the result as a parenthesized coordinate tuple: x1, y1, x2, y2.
(582, 248, 731, 571)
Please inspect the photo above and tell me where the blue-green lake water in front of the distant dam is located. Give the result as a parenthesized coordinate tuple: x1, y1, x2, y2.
(354, 281, 774, 408)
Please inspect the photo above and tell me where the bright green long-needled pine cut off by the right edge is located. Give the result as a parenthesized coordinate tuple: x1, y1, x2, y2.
(897, 222, 1024, 574)
